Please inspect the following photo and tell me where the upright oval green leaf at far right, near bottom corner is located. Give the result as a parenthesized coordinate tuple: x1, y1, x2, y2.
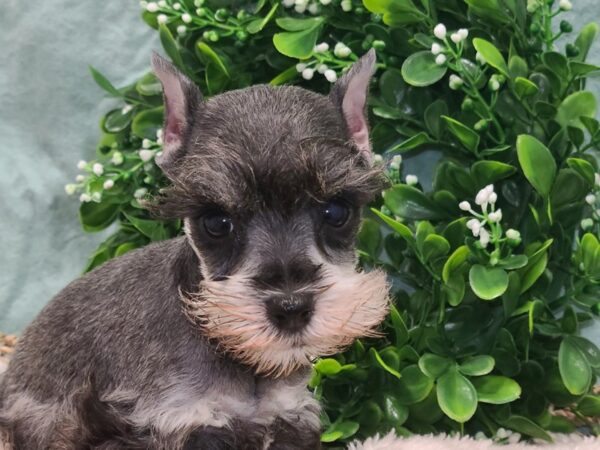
(558, 337, 592, 395)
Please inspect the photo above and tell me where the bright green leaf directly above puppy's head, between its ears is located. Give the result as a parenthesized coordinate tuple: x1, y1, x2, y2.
(273, 17, 323, 59)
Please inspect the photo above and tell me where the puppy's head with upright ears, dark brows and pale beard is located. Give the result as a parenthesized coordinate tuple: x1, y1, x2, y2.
(153, 52, 388, 375)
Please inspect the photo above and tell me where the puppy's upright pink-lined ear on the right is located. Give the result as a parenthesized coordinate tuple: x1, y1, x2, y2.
(329, 49, 375, 161)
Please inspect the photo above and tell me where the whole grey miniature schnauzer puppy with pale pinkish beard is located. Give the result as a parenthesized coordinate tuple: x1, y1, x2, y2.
(0, 51, 389, 450)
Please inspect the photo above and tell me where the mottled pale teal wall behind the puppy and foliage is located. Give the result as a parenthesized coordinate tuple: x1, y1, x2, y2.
(0, 0, 600, 343)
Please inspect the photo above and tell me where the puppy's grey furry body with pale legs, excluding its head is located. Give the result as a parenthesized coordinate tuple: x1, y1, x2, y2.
(2, 238, 319, 450)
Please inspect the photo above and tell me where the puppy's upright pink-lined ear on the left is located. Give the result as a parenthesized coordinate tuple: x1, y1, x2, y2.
(152, 53, 202, 176)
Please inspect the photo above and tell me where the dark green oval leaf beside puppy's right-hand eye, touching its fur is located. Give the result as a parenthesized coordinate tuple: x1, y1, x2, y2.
(383, 184, 443, 220)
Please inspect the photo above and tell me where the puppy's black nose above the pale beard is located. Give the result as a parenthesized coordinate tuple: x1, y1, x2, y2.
(266, 295, 314, 333)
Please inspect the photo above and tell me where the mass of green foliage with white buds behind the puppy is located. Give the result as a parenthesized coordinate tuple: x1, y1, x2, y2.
(67, 0, 600, 448)
